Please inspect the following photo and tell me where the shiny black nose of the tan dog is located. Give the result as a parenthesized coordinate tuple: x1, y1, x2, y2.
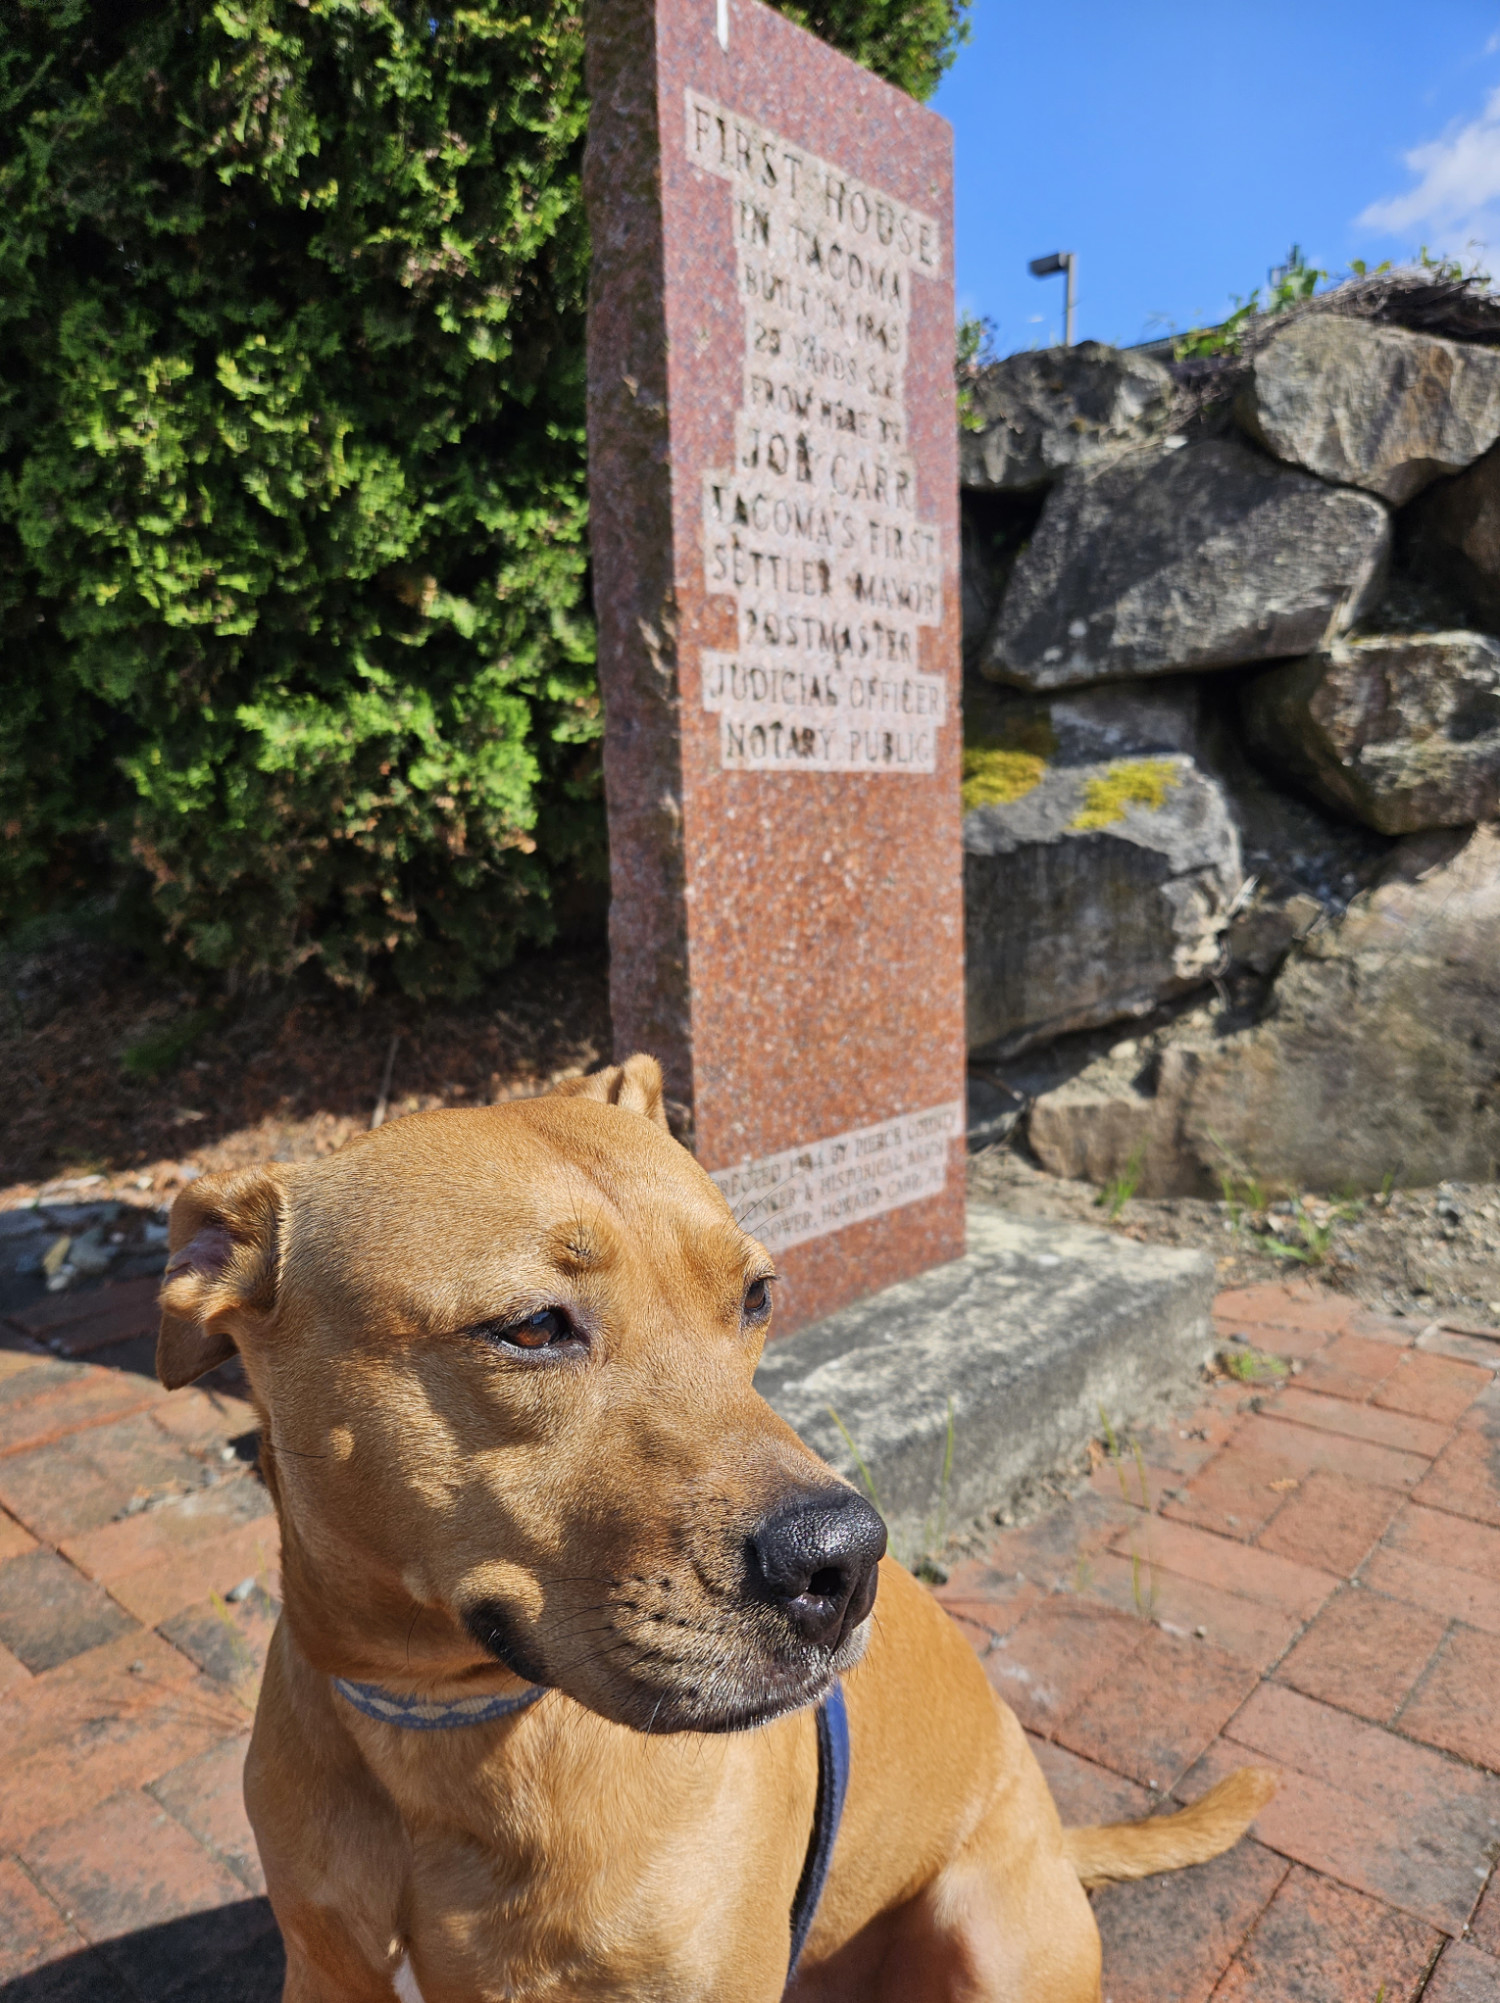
(749, 1488, 885, 1648)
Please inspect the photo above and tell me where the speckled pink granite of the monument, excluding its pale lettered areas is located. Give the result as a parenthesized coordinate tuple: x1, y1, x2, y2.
(585, 0, 963, 1332)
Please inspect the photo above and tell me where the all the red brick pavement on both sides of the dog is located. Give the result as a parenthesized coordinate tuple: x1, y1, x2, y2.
(0, 1282, 1500, 2003)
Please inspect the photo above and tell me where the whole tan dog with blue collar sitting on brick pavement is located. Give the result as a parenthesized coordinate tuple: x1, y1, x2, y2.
(158, 1058, 1270, 2003)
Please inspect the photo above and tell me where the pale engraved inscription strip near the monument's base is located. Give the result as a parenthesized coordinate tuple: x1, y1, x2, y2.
(713, 1102, 963, 1252)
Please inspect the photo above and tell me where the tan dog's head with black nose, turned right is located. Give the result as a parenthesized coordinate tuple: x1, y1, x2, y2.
(158, 1058, 885, 1731)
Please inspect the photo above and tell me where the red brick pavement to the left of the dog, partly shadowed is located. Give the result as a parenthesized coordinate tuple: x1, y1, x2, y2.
(0, 1280, 280, 2003)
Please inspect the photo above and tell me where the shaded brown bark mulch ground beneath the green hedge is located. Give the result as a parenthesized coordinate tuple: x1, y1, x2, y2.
(0, 935, 609, 1208)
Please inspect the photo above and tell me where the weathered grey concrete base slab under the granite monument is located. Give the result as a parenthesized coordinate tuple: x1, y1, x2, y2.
(755, 1204, 1214, 1560)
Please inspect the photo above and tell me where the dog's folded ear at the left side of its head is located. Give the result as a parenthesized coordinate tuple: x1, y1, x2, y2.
(156, 1168, 286, 1390)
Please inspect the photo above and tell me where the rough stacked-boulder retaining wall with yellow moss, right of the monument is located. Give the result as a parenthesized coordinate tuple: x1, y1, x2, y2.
(961, 278, 1500, 1194)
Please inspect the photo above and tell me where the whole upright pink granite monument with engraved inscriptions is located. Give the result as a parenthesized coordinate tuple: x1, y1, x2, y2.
(585, 0, 963, 1332)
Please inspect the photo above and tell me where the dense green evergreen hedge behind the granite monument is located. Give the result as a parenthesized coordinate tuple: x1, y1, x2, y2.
(0, 0, 967, 995)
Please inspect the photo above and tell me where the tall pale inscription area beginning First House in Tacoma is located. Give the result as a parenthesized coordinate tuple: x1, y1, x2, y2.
(687, 90, 945, 773)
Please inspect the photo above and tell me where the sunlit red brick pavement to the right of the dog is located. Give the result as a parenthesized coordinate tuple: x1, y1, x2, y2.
(939, 1282, 1500, 2003)
